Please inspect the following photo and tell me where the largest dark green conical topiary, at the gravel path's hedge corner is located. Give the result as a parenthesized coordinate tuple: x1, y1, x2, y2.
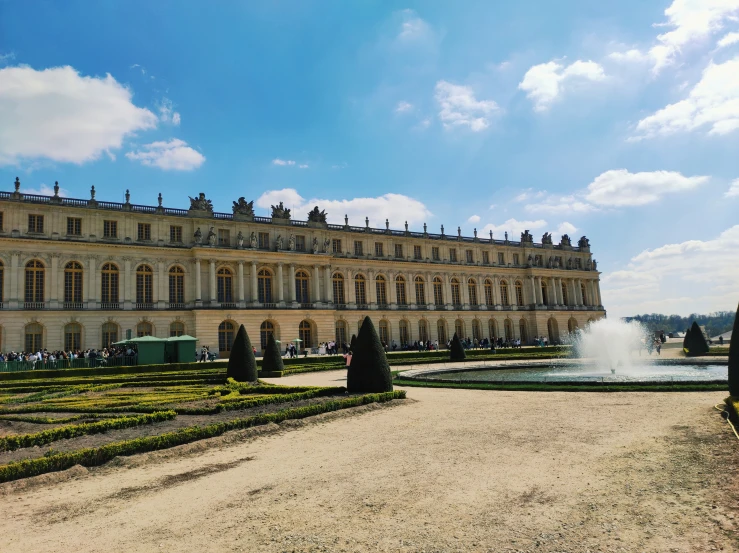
(346, 317, 393, 394)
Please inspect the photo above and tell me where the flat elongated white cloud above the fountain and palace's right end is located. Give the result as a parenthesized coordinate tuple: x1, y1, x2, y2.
(585, 169, 710, 207)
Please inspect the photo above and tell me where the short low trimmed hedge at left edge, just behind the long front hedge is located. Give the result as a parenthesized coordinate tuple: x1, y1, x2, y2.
(0, 411, 177, 451)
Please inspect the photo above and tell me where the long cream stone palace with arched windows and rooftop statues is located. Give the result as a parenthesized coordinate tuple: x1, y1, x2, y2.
(0, 178, 605, 356)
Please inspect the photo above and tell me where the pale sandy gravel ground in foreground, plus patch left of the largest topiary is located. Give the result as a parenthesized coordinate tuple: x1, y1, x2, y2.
(0, 371, 739, 553)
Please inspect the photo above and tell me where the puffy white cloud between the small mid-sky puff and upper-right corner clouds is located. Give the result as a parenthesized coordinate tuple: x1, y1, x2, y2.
(518, 60, 606, 111)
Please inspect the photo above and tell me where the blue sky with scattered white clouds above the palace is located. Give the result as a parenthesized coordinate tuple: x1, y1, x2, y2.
(0, 0, 739, 317)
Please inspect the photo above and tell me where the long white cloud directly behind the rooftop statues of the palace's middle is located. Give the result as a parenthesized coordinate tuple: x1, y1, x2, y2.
(255, 188, 433, 229)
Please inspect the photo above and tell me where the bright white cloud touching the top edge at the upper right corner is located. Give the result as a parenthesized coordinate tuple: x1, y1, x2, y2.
(649, 0, 739, 72)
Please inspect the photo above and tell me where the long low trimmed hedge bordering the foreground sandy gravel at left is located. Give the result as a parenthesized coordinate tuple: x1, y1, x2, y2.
(0, 390, 405, 482)
